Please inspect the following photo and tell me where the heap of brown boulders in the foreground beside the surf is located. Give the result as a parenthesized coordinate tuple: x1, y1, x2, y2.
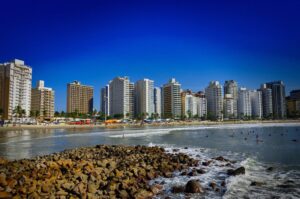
(0, 145, 198, 198)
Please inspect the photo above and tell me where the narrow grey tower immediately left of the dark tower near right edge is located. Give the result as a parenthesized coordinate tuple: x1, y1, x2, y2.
(259, 84, 273, 119)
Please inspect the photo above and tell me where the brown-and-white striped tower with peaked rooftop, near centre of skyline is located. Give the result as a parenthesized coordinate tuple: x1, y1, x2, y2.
(162, 78, 181, 118)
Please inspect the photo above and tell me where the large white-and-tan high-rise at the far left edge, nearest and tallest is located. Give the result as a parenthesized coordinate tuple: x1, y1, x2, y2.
(0, 59, 32, 119)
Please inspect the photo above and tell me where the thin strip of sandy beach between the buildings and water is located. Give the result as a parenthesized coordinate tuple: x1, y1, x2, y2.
(0, 120, 300, 132)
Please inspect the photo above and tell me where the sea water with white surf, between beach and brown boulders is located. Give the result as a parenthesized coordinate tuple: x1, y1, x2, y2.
(0, 123, 300, 198)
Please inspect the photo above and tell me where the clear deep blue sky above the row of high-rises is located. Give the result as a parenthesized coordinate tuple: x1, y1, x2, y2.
(0, 0, 300, 111)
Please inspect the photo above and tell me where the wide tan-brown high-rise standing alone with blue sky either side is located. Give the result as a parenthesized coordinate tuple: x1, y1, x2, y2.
(67, 81, 94, 114)
